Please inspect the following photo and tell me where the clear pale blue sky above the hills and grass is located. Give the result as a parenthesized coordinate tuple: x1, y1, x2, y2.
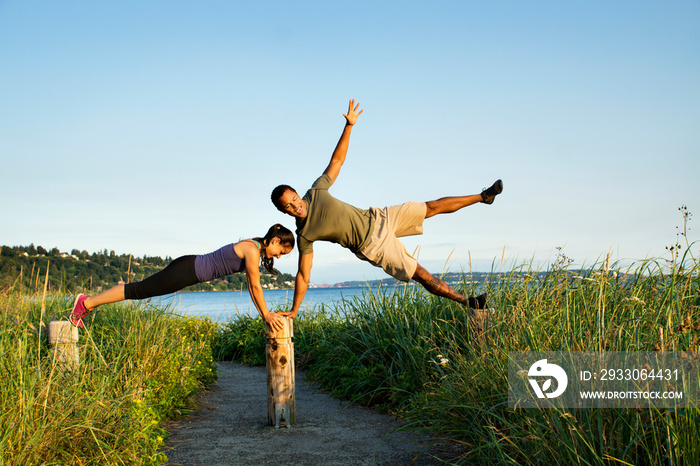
(0, 1, 700, 283)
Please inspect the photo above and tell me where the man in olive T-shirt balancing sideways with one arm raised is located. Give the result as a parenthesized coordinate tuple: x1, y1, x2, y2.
(271, 99, 503, 317)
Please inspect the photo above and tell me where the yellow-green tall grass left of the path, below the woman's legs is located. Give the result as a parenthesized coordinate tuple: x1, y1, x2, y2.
(0, 278, 217, 465)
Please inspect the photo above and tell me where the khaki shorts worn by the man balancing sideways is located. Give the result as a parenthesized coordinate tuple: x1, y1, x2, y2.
(356, 202, 427, 282)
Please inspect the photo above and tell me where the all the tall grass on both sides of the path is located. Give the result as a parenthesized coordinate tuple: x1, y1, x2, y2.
(5, 210, 700, 465)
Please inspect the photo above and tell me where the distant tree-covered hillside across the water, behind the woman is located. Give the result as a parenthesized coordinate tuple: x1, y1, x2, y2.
(0, 244, 294, 293)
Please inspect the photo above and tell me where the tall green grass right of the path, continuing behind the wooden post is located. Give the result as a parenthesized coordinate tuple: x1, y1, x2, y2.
(216, 244, 700, 465)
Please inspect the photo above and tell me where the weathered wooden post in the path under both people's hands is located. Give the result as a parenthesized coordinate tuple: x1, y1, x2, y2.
(265, 317, 296, 427)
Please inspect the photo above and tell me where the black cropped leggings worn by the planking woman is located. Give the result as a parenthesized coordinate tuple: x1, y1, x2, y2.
(124, 256, 200, 299)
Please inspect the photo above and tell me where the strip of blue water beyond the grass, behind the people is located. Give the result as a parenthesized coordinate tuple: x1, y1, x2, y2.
(154, 286, 382, 322)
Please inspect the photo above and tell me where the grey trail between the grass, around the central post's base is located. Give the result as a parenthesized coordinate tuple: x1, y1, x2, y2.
(164, 362, 460, 466)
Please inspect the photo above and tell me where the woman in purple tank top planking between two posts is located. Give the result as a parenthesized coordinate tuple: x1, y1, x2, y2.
(69, 223, 294, 330)
